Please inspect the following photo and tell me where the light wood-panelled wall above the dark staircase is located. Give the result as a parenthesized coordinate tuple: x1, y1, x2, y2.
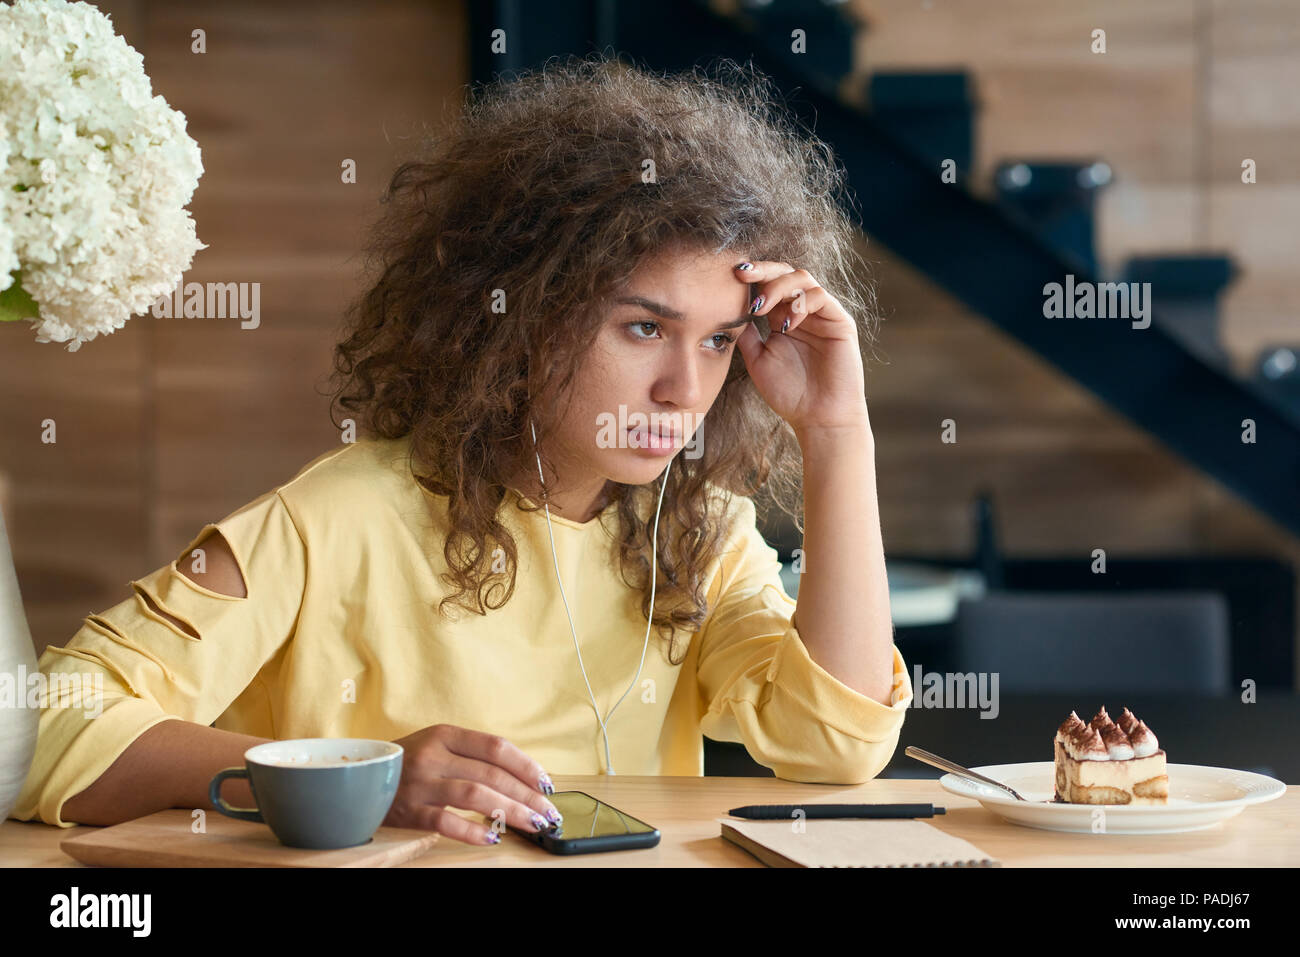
(850, 0, 1300, 371)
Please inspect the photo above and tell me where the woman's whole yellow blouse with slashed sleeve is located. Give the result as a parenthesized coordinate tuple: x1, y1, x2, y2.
(10, 429, 913, 827)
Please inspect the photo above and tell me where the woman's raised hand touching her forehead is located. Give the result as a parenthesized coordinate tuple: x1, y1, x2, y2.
(732, 261, 867, 433)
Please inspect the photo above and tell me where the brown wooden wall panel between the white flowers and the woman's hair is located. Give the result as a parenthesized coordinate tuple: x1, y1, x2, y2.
(139, 0, 468, 562)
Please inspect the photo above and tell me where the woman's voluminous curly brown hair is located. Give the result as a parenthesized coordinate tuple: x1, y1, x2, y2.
(330, 55, 879, 661)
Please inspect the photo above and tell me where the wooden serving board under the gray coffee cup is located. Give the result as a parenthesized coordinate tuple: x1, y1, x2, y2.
(59, 807, 439, 867)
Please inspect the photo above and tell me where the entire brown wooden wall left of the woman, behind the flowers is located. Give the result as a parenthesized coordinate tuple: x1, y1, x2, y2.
(0, 0, 468, 653)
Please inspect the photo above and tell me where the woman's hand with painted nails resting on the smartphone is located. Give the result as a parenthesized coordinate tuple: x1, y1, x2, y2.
(384, 724, 563, 844)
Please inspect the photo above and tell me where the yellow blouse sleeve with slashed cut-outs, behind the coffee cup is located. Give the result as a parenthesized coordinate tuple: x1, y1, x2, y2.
(10, 492, 307, 827)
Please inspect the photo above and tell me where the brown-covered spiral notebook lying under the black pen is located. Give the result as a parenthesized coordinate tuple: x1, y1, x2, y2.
(718, 818, 1002, 867)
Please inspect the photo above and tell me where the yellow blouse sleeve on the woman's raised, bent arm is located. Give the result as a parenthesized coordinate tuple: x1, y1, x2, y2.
(697, 498, 913, 784)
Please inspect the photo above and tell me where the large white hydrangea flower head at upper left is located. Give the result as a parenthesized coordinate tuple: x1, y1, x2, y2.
(0, 0, 207, 352)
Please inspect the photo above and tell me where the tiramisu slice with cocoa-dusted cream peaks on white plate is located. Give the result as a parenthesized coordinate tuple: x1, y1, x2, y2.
(1054, 707, 1169, 805)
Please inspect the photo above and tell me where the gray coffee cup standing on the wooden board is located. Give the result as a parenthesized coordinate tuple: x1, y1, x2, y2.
(208, 737, 403, 849)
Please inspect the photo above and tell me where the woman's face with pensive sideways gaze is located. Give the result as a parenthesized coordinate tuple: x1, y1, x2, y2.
(525, 252, 753, 521)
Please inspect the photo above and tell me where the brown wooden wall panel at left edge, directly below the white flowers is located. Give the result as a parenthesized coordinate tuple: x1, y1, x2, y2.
(0, 265, 152, 650)
